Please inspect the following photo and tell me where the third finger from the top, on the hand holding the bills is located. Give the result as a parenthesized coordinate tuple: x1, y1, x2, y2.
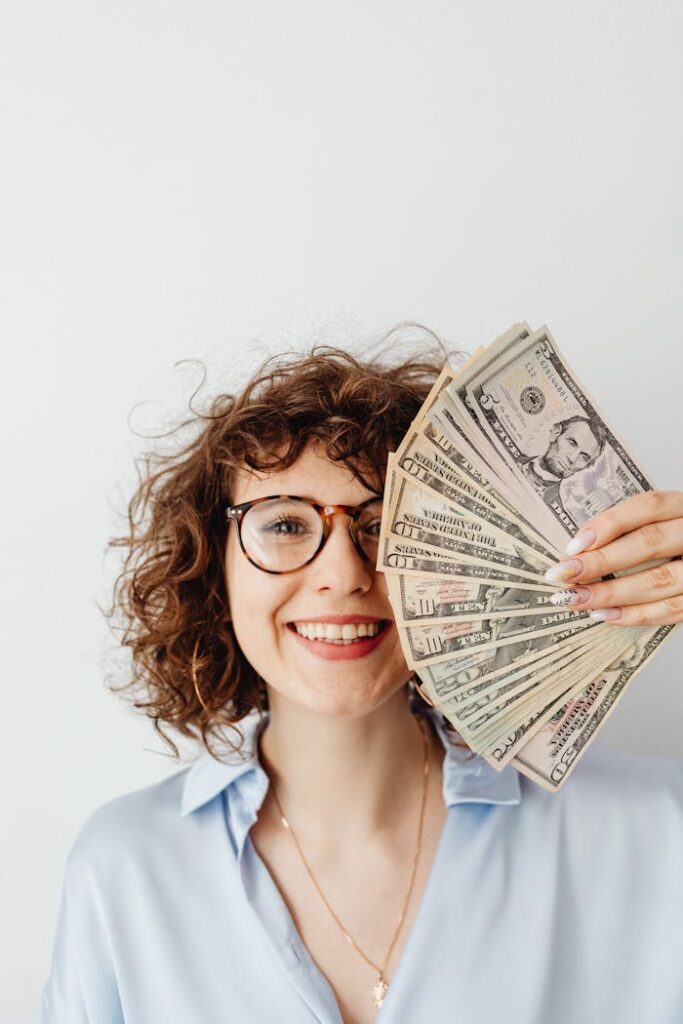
(551, 559, 683, 625)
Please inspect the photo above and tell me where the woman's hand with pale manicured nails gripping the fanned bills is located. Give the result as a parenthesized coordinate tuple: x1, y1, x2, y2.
(546, 490, 683, 626)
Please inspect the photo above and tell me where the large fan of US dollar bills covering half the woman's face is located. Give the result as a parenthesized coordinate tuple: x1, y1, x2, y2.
(378, 324, 674, 792)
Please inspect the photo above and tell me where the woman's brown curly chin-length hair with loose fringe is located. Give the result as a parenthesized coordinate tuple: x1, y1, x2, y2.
(106, 323, 466, 759)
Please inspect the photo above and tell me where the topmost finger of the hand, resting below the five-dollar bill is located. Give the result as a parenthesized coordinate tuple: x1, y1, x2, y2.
(566, 490, 683, 556)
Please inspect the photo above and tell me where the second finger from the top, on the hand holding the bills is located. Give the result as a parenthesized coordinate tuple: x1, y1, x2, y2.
(546, 518, 683, 584)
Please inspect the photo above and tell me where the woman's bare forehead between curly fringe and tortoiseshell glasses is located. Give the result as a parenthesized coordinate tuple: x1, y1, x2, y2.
(230, 444, 375, 505)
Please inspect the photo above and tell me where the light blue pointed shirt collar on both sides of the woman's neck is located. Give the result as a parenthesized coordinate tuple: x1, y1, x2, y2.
(180, 708, 521, 817)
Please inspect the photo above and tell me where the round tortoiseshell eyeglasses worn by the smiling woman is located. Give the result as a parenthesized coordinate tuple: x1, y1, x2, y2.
(225, 495, 382, 573)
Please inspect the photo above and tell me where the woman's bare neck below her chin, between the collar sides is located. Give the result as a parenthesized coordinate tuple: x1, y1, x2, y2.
(254, 689, 443, 849)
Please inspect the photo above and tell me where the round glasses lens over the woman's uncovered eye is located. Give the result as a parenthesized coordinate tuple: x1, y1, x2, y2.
(242, 498, 323, 572)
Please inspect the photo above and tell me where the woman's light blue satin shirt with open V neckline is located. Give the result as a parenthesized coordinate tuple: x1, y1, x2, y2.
(42, 711, 683, 1024)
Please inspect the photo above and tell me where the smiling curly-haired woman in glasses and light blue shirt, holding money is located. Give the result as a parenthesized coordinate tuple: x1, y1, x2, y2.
(43, 337, 683, 1024)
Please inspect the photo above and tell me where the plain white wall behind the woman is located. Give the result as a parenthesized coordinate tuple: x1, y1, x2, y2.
(0, 0, 683, 1024)
